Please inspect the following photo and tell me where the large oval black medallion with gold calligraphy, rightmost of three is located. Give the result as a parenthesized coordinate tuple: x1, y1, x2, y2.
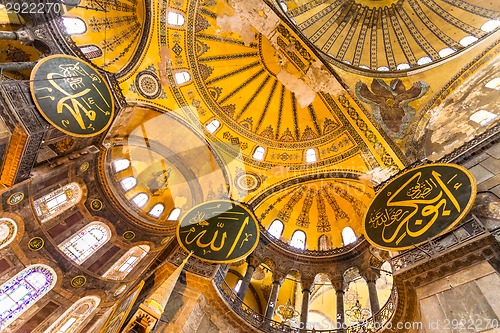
(363, 164, 476, 251)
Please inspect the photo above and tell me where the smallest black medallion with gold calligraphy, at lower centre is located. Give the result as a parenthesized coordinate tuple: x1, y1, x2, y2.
(177, 200, 260, 263)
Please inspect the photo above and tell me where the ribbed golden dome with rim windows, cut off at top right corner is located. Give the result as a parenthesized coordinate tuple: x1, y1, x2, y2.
(279, 0, 500, 75)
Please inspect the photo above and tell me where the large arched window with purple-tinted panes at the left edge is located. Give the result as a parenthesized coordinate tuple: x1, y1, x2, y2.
(0, 265, 57, 331)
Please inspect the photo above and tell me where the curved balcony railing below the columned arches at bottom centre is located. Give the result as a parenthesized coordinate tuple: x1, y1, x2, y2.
(213, 268, 397, 333)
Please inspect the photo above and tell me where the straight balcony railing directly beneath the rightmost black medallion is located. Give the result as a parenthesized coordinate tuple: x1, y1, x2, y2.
(391, 215, 488, 272)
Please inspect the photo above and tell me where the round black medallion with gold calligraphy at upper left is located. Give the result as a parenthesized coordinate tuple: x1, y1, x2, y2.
(31, 54, 114, 137)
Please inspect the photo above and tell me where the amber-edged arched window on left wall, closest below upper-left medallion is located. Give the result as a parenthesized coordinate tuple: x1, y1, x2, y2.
(34, 183, 82, 222)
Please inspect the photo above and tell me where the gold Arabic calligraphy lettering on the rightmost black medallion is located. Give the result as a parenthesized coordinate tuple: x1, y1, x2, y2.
(368, 171, 462, 245)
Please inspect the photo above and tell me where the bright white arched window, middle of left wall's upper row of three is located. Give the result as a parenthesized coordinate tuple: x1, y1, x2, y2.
(59, 222, 111, 265)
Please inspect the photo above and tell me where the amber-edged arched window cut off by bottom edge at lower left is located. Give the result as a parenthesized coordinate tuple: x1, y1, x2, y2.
(44, 296, 101, 333)
